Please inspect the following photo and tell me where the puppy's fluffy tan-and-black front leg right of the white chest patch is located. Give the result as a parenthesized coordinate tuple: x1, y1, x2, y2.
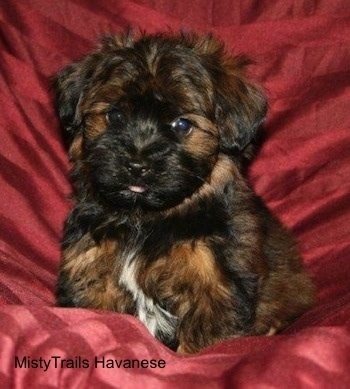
(139, 241, 257, 353)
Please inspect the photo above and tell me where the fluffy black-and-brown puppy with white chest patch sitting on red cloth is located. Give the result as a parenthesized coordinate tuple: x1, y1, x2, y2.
(55, 33, 314, 353)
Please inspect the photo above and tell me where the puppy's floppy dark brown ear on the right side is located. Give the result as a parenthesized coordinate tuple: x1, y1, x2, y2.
(215, 57, 267, 154)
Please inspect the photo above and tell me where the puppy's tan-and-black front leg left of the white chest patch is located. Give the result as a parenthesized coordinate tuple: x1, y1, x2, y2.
(57, 235, 133, 312)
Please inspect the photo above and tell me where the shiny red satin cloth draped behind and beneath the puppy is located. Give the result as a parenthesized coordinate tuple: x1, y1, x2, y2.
(0, 0, 350, 389)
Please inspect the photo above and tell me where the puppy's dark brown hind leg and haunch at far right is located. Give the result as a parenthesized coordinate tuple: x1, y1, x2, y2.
(254, 212, 315, 335)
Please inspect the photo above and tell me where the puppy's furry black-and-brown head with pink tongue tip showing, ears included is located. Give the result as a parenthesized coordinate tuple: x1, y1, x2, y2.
(55, 31, 266, 210)
